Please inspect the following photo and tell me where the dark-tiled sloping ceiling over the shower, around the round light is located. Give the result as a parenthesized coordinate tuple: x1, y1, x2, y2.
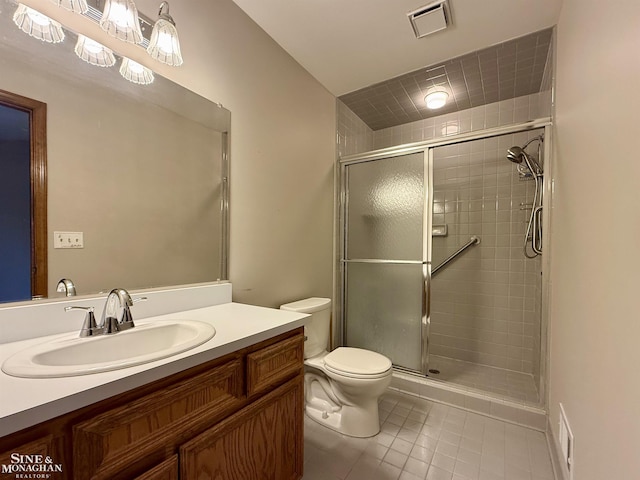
(339, 28, 553, 131)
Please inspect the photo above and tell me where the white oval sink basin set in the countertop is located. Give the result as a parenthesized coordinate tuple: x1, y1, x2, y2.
(2, 320, 216, 378)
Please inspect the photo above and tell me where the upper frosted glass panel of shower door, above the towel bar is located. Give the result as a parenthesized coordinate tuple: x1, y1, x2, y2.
(346, 152, 425, 260)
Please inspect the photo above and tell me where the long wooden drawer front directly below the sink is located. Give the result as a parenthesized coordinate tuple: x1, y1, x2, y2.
(73, 358, 244, 480)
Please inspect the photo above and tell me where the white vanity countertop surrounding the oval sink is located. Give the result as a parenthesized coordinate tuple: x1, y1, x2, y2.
(0, 303, 308, 437)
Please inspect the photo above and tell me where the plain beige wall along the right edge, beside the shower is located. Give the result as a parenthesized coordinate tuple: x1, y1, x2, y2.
(550, 0, 640, 480)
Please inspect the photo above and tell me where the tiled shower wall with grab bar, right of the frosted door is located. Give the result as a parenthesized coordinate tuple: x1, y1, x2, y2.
(430, 129, 541, 374)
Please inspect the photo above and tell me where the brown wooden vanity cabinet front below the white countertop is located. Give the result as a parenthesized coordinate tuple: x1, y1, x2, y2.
(0, 328, 304, 480)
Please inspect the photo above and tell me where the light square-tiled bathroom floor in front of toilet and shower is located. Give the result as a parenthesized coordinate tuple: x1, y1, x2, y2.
(303, 391, 554, 480)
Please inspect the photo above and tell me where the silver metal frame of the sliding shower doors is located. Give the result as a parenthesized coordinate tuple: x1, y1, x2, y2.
(334, 118, 552, 386)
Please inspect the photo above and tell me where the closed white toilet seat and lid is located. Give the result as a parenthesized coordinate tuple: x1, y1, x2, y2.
(323, 347, 391, 379)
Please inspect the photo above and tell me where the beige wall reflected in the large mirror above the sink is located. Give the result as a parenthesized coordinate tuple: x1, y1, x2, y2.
(0, 0, 231, 302)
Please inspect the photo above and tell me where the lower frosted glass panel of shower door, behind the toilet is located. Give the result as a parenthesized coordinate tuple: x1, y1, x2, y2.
(345, 263, 422, 371)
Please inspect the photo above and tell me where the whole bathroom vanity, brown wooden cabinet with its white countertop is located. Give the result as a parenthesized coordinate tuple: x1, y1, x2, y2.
(0, 286, 305, 480)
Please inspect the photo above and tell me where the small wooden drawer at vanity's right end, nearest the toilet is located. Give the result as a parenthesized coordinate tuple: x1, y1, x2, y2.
(247, 334, 304, 397)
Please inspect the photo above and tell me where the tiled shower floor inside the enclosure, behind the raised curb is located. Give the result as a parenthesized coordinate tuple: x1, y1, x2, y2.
(429, 355, 540, 406)
